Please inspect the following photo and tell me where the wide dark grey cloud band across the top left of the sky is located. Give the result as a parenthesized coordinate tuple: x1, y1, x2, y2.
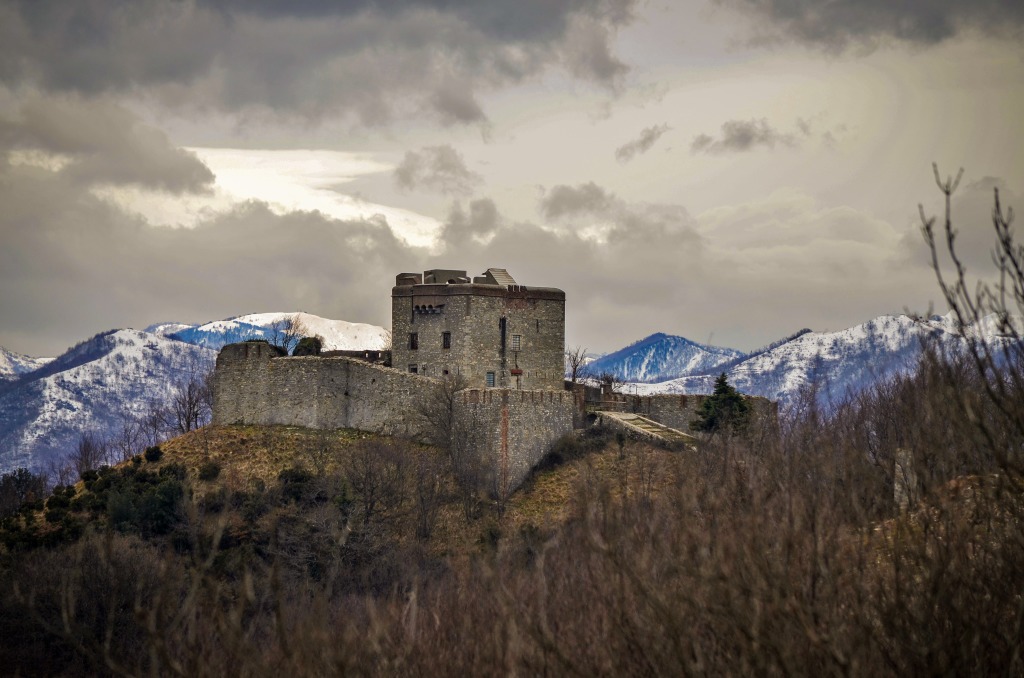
(0, 0, 635, 124)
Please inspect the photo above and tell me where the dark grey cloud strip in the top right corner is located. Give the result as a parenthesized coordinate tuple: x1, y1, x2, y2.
(718, 0, 1024, 50)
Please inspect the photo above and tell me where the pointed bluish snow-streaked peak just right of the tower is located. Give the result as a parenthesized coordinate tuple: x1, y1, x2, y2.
(587, 332, 743, 383)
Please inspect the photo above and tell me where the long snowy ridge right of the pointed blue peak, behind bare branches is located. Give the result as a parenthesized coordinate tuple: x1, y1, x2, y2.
(625, 314, 1015, 406)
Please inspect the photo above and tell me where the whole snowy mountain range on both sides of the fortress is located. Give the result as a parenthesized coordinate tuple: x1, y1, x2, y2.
(0, 312, 1015, 472)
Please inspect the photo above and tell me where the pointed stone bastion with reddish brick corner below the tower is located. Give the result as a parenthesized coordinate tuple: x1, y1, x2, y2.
(455, 388, 575, 496)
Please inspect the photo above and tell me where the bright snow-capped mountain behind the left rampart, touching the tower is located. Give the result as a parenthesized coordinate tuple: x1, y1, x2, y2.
(147, 312, 391, 350)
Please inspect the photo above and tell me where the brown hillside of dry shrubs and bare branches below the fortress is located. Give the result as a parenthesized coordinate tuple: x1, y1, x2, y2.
(0, 393, 1024, 676)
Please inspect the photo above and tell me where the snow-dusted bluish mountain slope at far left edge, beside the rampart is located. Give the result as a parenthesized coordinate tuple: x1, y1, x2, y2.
(0, 330, 216, 472)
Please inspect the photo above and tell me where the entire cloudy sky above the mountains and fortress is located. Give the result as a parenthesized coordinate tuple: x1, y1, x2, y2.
(0, 0, 1024, 355)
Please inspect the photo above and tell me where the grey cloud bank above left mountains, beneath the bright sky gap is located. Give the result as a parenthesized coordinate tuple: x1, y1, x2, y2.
(0, 151, 419, 355)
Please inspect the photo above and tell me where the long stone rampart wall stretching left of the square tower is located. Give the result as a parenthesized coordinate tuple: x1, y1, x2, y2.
(213, 343, 436, 436)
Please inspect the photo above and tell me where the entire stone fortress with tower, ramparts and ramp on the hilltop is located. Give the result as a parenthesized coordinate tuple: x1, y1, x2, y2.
(213, 268, 774, 495)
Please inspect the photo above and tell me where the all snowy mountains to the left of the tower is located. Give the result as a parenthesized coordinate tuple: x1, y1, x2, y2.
(0, 313, 390, 472)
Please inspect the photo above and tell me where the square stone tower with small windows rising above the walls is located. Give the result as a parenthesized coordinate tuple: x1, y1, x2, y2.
(391, 268, 565, 390)
